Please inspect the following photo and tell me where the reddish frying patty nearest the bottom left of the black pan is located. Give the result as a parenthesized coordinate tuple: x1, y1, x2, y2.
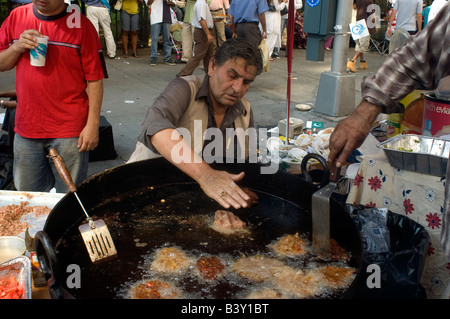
(131, 280, 181, 299)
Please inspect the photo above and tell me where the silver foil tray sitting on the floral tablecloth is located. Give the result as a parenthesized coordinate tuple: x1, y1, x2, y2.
(377, 134, 450, 177)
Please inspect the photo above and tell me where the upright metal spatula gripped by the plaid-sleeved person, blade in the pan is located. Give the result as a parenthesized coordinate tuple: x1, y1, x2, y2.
(311, 168, 341, 258)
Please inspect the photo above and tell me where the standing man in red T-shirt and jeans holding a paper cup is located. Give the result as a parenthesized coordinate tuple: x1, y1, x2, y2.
(0, 0, 107, 192)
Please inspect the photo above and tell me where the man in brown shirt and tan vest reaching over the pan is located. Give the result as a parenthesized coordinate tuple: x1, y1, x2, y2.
(132, 39, 262, 208)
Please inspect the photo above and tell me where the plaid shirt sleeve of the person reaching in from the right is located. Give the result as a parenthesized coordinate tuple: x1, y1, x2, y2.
(361, 5, 450, 114)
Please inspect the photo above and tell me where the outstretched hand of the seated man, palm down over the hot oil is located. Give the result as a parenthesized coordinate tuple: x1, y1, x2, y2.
(198, 169, 250, 209)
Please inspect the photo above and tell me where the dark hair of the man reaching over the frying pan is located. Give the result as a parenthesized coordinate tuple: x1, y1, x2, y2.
(213, 38, 263, 75)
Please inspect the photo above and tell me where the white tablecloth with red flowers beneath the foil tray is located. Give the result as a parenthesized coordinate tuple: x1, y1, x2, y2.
(347, 153, 450, 299)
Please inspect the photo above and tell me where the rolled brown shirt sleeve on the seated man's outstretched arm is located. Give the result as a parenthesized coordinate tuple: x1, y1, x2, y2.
(138, 78, 191, 152)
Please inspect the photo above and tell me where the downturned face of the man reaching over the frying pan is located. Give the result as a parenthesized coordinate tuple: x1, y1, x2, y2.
(208, 58, 257, 107)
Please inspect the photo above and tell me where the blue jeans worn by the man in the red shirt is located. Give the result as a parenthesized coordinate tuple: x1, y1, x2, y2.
(13, 134, 89, 193)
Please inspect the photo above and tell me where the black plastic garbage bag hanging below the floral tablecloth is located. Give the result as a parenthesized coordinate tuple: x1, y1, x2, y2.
(348, 205, 430, 299)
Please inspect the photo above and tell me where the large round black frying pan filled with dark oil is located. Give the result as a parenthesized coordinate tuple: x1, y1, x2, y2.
(36, 158, 361, 298)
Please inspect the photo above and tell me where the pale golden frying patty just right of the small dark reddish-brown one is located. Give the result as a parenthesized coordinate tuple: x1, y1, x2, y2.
(232, 255, 287, 282)
